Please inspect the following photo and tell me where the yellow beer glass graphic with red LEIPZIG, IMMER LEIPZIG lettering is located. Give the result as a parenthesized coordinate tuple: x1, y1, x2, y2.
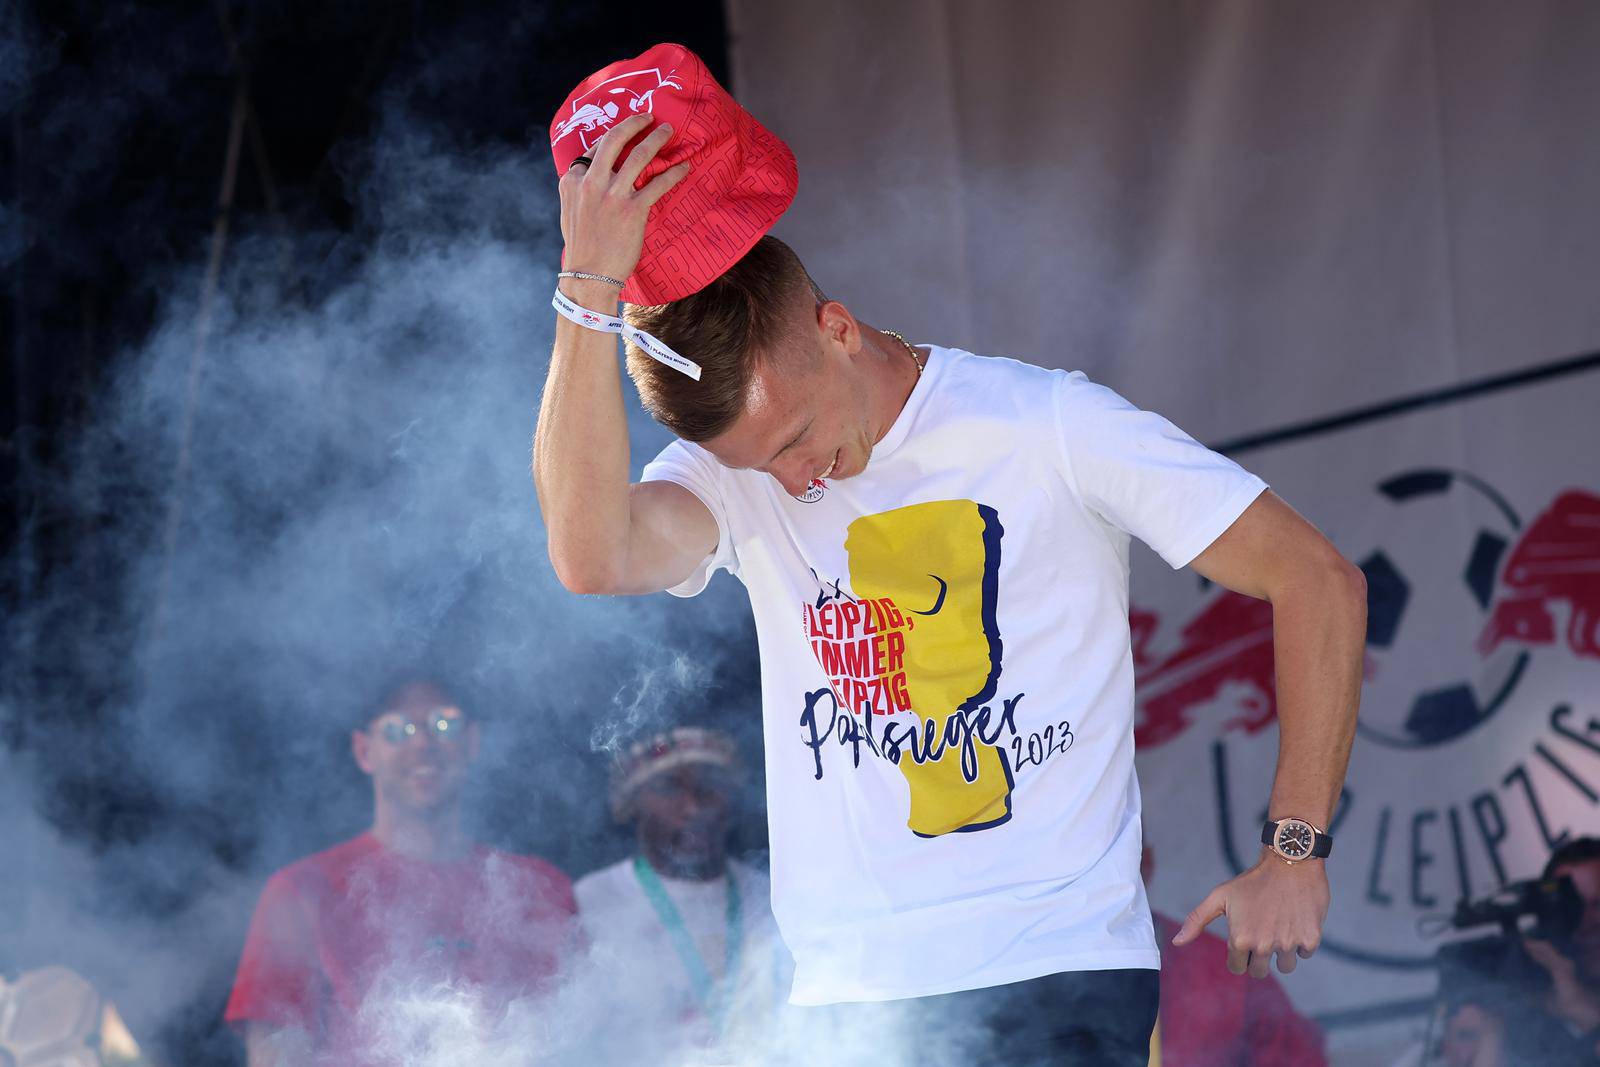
(800, 501, 1013, 837)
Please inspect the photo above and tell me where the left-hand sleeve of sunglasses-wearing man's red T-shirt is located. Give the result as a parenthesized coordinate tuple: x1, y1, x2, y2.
(224, 872, 326, 1033)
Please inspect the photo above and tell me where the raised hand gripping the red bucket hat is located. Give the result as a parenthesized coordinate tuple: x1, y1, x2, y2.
(560, 112, 690, 286)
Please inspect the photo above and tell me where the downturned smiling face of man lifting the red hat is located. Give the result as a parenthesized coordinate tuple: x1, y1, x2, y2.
(704, 304, 878, 496)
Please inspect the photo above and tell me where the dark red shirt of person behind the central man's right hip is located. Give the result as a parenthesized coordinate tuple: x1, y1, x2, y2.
(1155, 915, 1328, 1067)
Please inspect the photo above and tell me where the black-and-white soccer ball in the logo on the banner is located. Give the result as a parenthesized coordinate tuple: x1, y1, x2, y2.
(1349, 467, 1528, 749)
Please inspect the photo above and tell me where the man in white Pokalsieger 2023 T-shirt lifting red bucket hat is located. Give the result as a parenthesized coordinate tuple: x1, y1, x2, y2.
(534, 45, 1365, 1064)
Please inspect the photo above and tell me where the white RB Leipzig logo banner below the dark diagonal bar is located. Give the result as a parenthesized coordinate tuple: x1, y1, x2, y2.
(1130, 360, 1600, 1064)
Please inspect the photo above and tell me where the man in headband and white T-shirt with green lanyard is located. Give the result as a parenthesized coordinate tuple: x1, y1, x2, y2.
(574, 726, 790, 1062)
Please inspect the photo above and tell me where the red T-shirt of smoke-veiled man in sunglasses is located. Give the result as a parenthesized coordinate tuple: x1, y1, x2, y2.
(226, 833, 578, 1064)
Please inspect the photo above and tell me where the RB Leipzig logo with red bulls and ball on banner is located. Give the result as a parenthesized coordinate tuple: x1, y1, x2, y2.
(1130, 469, 1600, 968)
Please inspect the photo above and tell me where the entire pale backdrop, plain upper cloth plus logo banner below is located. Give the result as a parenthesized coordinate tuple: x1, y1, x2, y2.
(728, 0, 1600, 1064)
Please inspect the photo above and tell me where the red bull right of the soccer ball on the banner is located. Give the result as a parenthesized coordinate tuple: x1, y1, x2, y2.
(1477, 490, 1600, 657)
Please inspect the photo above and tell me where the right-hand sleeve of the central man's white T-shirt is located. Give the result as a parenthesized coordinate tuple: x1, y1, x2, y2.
(1056, 371, 1267, 569)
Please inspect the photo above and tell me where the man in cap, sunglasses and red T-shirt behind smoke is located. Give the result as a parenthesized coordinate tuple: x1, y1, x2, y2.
(226, 681, 576, 1067)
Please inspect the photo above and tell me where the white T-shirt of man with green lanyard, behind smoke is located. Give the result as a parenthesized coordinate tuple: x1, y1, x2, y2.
(573, 856, 794, 1054)
